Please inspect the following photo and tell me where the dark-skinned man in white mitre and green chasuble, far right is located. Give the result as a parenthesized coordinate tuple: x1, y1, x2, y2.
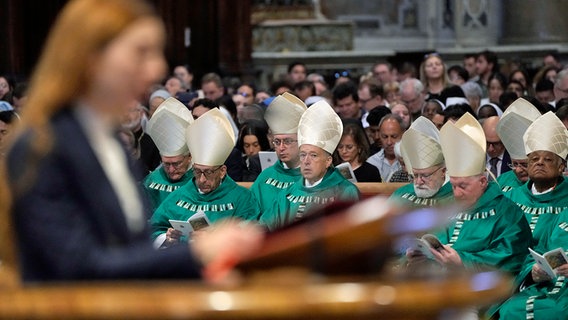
(509, 112, 568, 248)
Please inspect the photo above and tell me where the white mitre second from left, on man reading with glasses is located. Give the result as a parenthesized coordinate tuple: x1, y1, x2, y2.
(186, 108, 235, 166)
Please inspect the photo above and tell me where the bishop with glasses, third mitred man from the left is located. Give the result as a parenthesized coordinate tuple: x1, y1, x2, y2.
(250, 92, 307, 213)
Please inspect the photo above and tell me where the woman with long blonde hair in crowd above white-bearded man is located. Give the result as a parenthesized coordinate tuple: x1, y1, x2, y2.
(420, 53, 451, 99)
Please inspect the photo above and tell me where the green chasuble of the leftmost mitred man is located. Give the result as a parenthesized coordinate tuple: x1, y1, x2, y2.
(142, 166, 193, 212)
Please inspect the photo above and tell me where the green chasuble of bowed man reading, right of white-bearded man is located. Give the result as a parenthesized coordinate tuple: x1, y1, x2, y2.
(436, 182, 531, 274)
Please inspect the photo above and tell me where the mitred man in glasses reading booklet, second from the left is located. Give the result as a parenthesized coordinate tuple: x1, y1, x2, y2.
(150, 108, 260, 248)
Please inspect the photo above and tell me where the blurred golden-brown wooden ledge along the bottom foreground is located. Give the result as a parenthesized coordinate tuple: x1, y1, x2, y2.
(0, 273, 510, 319)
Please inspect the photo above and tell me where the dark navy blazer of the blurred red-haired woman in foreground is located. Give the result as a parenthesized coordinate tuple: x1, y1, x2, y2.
(8, 109, 201, 281)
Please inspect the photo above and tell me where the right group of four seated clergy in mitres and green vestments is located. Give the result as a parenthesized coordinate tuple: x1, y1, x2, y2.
(391, 101, 568, 319)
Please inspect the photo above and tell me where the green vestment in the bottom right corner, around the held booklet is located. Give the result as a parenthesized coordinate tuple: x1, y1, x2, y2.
(492, 210, 568, 320)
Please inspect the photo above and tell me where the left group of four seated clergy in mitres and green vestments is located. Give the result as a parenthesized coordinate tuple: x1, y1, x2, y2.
(144, 95, 359, 247)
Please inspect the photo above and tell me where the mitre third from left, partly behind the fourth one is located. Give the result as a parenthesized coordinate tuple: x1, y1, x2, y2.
(264, 92, 307, 134)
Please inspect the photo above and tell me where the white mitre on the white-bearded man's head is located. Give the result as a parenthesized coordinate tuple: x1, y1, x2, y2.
(400, 116, 444, 171)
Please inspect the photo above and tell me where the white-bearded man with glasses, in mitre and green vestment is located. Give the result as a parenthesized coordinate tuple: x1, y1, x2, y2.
(390, 117, 454, 207)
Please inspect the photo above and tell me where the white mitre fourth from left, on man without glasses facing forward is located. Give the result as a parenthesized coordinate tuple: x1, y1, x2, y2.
(298, 100, 343, 154)
